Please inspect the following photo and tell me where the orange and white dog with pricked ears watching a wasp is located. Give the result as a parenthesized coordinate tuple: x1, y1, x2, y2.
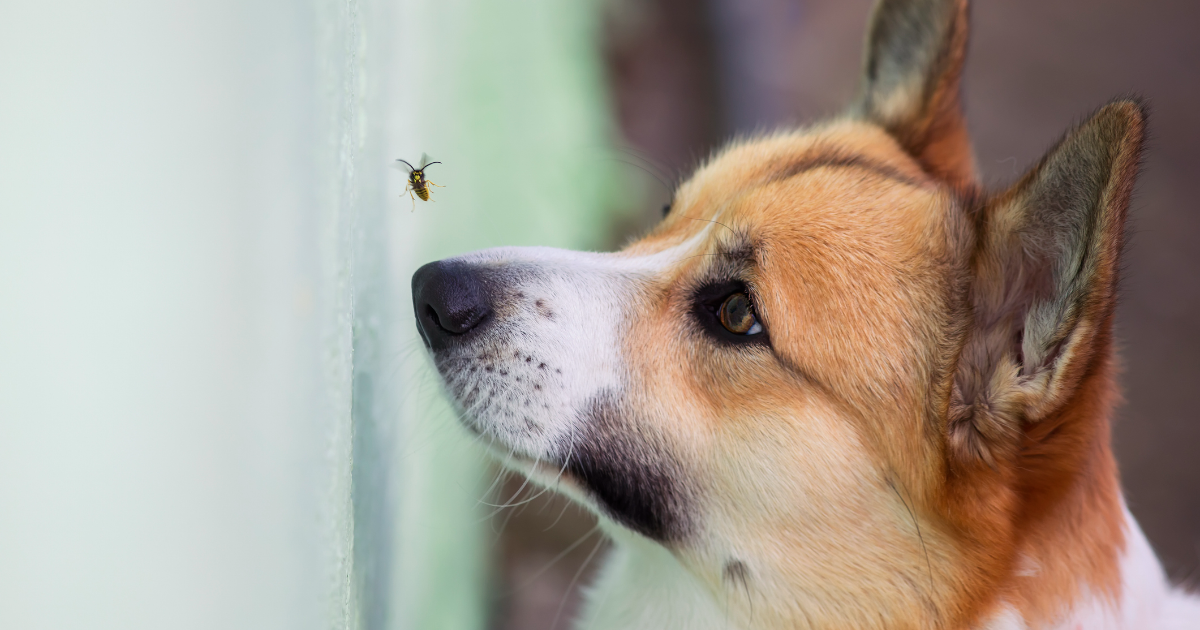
(413, 0, 1200, 630)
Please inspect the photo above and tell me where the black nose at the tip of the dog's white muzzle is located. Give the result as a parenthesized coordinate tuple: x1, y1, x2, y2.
(413, 262, 492, 349)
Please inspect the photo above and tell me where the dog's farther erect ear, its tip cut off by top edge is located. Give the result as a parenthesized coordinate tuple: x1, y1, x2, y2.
(851, 0, 977, 187)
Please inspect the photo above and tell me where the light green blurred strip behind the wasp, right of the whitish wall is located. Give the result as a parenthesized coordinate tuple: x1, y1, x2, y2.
(343, 0, 628, 630)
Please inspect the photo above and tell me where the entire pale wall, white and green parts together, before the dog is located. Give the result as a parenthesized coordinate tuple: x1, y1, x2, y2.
(0, 0, 620, 630)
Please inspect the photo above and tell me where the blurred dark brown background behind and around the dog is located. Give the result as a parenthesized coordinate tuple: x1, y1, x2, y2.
(493, 0, 1200, 630)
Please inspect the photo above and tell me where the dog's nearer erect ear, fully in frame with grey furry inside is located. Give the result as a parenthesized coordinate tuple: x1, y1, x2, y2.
(948, 101, 1145, 466)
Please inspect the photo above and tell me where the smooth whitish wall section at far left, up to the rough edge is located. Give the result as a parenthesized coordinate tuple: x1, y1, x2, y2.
(0, 0, 338, 629)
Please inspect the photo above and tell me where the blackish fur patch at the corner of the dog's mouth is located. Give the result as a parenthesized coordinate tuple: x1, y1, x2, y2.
(564, 392, 691, 542)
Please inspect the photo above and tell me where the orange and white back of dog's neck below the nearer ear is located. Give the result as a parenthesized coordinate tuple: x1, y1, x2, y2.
(983, 344, 1200, 630)
